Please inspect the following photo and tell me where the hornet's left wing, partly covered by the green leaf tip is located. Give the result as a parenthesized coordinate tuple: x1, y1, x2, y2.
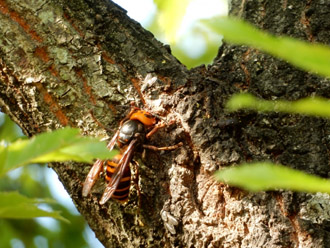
(82, 130, 119, 197)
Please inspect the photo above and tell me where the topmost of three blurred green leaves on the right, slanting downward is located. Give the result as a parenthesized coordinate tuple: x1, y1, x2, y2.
(203, 17, 330, 77)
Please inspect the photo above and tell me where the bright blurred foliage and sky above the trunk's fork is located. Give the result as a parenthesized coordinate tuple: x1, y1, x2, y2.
(114, 0, 228, 68)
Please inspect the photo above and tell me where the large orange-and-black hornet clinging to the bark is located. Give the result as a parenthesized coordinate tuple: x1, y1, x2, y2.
(82, 107, 182, 204)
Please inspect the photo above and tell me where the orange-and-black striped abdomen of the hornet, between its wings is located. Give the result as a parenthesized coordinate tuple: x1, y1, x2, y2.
(105, 154, 131, 203)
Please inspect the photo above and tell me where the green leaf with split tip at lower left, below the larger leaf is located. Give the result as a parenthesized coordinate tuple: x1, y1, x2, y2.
(0, 192, 68, 222)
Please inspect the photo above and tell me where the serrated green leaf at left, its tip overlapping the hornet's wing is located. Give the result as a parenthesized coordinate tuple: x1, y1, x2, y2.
(0, 128, 116, 176)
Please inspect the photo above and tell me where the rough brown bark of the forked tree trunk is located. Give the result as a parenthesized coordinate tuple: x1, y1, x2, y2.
(0, 0, 330, 247)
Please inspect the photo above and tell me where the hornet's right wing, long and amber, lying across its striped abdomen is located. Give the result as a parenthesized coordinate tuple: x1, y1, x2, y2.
(100, 140, 137, 205)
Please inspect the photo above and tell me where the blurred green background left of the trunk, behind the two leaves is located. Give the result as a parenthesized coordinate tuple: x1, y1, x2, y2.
(0, 114, 103, 248)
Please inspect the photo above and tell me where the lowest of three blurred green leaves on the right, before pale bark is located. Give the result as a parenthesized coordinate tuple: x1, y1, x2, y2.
(215, 162, 330, 193)
